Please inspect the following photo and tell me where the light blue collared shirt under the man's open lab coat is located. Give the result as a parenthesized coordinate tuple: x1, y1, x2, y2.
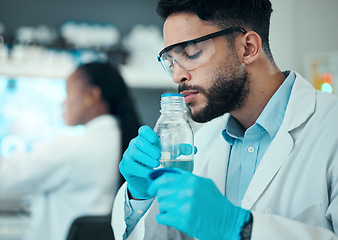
(222, 72, 296, 206)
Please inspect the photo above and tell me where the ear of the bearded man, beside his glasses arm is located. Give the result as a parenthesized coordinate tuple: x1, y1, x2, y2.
(240, 31, 262, 65)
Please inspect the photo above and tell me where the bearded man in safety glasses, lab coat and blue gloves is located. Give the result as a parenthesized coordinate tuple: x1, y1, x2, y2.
(112, 0, 338, 240)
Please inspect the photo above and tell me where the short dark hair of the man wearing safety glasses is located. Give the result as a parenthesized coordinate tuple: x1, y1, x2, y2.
(157, 0, 273, 60)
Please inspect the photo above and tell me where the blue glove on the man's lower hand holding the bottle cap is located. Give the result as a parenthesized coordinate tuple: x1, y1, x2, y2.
(148, 168, 250, 240)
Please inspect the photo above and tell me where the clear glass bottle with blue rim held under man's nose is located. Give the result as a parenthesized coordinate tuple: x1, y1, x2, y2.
(154, 93, 194, 172)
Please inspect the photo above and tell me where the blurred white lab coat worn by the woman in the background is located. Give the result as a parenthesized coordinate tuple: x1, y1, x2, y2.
(0, 115, 121, 240)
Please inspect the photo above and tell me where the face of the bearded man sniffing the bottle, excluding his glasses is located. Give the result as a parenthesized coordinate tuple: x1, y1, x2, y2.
(163, 13, 249, 122)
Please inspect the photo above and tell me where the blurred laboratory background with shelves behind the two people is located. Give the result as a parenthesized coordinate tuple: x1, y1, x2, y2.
(0, 0, 338, 240)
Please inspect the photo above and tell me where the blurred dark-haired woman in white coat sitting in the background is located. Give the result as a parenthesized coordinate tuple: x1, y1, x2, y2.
(0, 63, 139, 240)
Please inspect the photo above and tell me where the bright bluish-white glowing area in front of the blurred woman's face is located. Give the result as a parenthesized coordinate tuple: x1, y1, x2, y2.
(0, 76, 68, 158)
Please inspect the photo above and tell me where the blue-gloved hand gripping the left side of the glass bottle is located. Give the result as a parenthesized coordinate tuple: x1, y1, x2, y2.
(119, 126, 161, 199)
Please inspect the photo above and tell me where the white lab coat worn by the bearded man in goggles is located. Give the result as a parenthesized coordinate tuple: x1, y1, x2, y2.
(112, 74, 338, 240)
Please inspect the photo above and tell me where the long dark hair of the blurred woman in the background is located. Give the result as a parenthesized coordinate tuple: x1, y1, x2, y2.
(77, 62, 140, 158)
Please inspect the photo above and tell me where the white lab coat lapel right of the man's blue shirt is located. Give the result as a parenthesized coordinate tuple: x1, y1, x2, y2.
(242, 73, 316, 209)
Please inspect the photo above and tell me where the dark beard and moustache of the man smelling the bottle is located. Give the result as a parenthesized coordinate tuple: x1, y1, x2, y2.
(179, 64, 250, 123)
